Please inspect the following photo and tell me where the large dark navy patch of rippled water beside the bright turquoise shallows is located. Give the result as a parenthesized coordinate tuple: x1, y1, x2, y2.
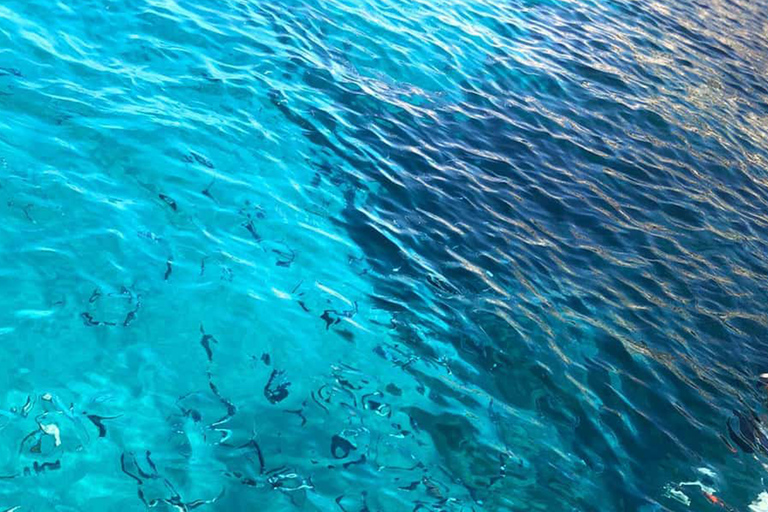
(260, 2, 768, 510)
